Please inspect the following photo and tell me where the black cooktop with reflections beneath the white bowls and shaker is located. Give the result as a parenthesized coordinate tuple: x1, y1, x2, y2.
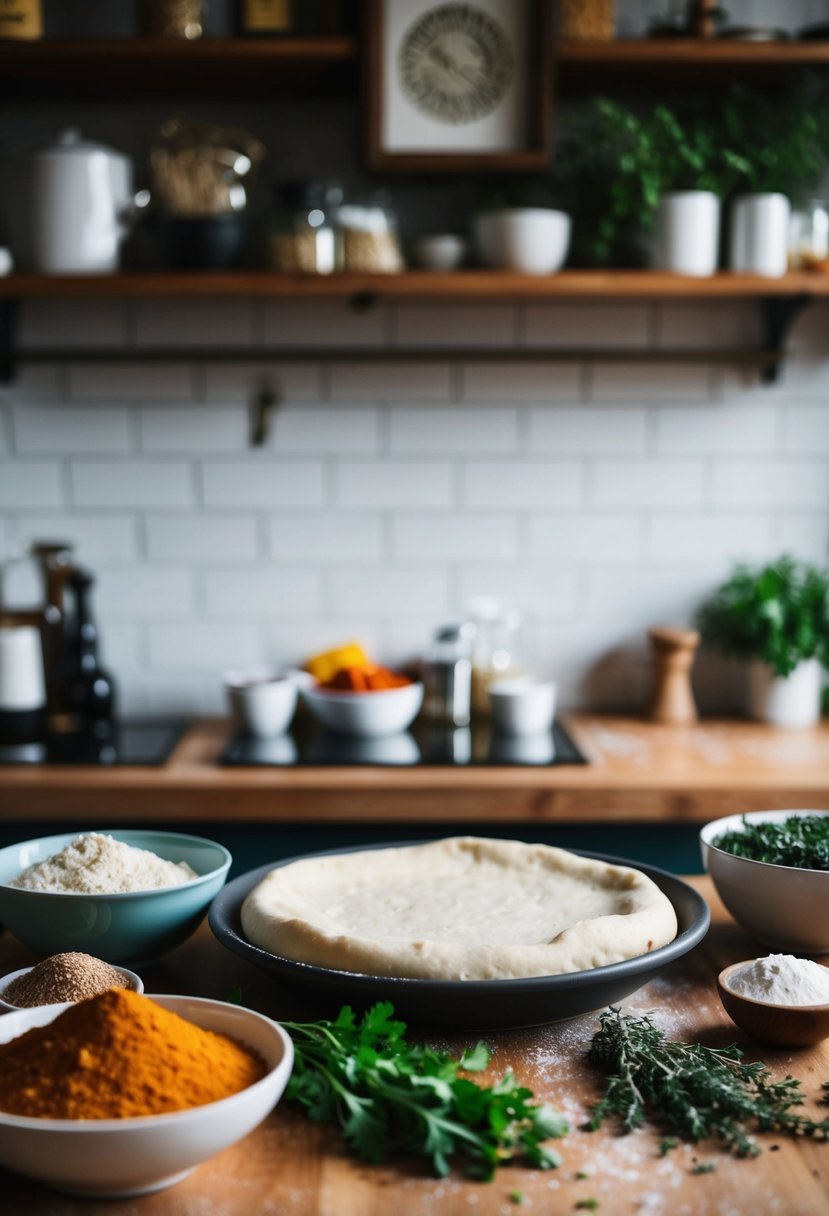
(219, 717, 587, 769)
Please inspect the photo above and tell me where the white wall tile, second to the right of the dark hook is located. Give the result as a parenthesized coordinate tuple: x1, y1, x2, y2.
(389, 405, 518, 454)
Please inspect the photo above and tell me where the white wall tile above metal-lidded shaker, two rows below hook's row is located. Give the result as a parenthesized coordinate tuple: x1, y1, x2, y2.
(391, 514, 519, 563)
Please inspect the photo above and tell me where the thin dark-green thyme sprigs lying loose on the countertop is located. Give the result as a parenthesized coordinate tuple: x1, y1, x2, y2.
(587, 1007, 829, 1156)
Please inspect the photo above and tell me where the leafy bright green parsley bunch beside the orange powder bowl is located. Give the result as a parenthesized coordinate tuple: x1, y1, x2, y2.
(282, 1001, 568, 1180)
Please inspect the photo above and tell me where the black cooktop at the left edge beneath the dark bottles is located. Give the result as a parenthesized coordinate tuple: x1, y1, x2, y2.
(0, 717, 187, 765)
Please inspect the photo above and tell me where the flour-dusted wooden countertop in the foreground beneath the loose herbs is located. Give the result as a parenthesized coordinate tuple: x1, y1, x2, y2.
(0, 878, 829, 1216)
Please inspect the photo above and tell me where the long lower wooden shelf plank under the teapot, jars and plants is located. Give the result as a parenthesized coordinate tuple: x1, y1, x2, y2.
(0, 270, 829, 300)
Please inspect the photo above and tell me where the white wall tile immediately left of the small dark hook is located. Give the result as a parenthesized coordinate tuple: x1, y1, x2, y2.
(139, 405, 250, 454)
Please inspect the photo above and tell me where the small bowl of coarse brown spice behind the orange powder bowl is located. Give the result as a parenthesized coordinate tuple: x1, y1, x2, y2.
(0, 950, 143, 1010)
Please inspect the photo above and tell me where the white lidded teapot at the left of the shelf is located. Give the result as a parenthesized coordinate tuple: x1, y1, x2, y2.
(15, 128, 150, 275)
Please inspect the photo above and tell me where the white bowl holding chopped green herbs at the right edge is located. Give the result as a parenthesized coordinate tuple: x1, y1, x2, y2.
(699, 810, 829, 955)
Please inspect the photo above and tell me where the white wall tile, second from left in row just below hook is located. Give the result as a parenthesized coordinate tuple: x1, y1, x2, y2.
(71, 460, 196, 508)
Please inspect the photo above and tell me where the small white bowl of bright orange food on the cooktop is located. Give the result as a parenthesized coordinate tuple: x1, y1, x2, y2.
(299, 664, 423, 738)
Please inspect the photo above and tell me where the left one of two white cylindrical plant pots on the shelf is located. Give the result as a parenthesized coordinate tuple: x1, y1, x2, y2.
(654, 190, 720, 277)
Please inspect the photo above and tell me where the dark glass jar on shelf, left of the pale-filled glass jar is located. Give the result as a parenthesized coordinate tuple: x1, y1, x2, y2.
(267, 181, 342, 275)
